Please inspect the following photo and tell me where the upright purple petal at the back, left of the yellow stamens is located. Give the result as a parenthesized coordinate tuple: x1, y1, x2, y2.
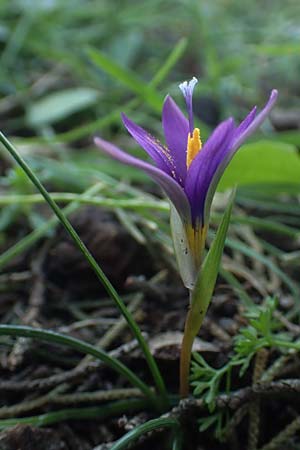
(162, 95, 189, 184)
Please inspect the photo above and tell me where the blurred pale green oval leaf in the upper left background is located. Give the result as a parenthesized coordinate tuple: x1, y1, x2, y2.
(26, 88, 99, 127)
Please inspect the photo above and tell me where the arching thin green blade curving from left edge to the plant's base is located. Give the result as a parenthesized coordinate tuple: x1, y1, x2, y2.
(0, 325, 156, 402)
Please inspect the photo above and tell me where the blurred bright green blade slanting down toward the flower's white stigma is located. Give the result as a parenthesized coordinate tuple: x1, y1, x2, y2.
(87, 48, 162, 112)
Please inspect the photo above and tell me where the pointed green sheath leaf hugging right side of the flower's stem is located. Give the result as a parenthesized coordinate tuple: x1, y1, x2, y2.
(190, 191, 235, 336)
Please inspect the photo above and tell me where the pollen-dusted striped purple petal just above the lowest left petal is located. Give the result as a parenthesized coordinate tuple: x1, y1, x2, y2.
(122, 113, 176, 176)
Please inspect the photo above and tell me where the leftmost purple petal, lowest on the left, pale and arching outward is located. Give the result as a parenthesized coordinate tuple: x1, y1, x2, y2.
(94, 137, 191, 222)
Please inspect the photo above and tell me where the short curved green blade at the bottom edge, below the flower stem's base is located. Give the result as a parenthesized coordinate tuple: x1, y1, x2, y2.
(110, 417, 180, 450)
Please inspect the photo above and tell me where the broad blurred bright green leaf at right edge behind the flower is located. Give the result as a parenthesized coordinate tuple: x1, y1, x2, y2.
(218, 140, 300, 191)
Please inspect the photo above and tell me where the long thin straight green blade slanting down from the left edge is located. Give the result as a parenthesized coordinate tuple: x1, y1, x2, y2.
(0, 132, 168, 406)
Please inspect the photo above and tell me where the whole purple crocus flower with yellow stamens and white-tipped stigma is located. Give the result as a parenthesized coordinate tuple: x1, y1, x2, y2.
(95, 78, 277, 289)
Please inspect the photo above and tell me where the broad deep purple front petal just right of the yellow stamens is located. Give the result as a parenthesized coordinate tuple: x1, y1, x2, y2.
(185, 118, 235, 226)
